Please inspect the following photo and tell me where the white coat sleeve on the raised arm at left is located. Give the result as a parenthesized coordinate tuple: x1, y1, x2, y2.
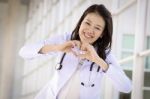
(19, 34, 70, 59)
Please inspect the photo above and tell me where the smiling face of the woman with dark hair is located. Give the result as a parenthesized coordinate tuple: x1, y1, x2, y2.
(79, 13, 105, 44)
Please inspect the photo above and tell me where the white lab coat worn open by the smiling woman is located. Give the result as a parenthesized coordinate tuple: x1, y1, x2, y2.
(19, 34, 131, 99)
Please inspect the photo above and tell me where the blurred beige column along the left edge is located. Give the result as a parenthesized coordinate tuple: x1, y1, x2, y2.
(0, 0, 26, 99)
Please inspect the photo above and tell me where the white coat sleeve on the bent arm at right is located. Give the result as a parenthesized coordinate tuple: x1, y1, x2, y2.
(105, 52, 132, 93)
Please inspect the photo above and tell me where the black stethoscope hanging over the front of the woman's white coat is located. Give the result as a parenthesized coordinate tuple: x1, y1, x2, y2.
(55, 53, 100, 87)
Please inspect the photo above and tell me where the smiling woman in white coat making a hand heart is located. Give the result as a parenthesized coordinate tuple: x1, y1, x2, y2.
(20, 4, 131, 99)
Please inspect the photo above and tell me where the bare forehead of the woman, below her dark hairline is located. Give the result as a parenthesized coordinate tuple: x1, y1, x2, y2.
(84, 13, 105, 26)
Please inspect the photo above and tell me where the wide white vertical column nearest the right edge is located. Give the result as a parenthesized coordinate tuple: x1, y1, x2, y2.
(132, 0, 147, 99)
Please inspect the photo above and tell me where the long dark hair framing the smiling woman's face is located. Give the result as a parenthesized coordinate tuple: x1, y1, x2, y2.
(71, 4, 113, 60)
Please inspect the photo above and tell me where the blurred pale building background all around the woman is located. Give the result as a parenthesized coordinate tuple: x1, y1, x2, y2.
(0, 0, 150, 99)
